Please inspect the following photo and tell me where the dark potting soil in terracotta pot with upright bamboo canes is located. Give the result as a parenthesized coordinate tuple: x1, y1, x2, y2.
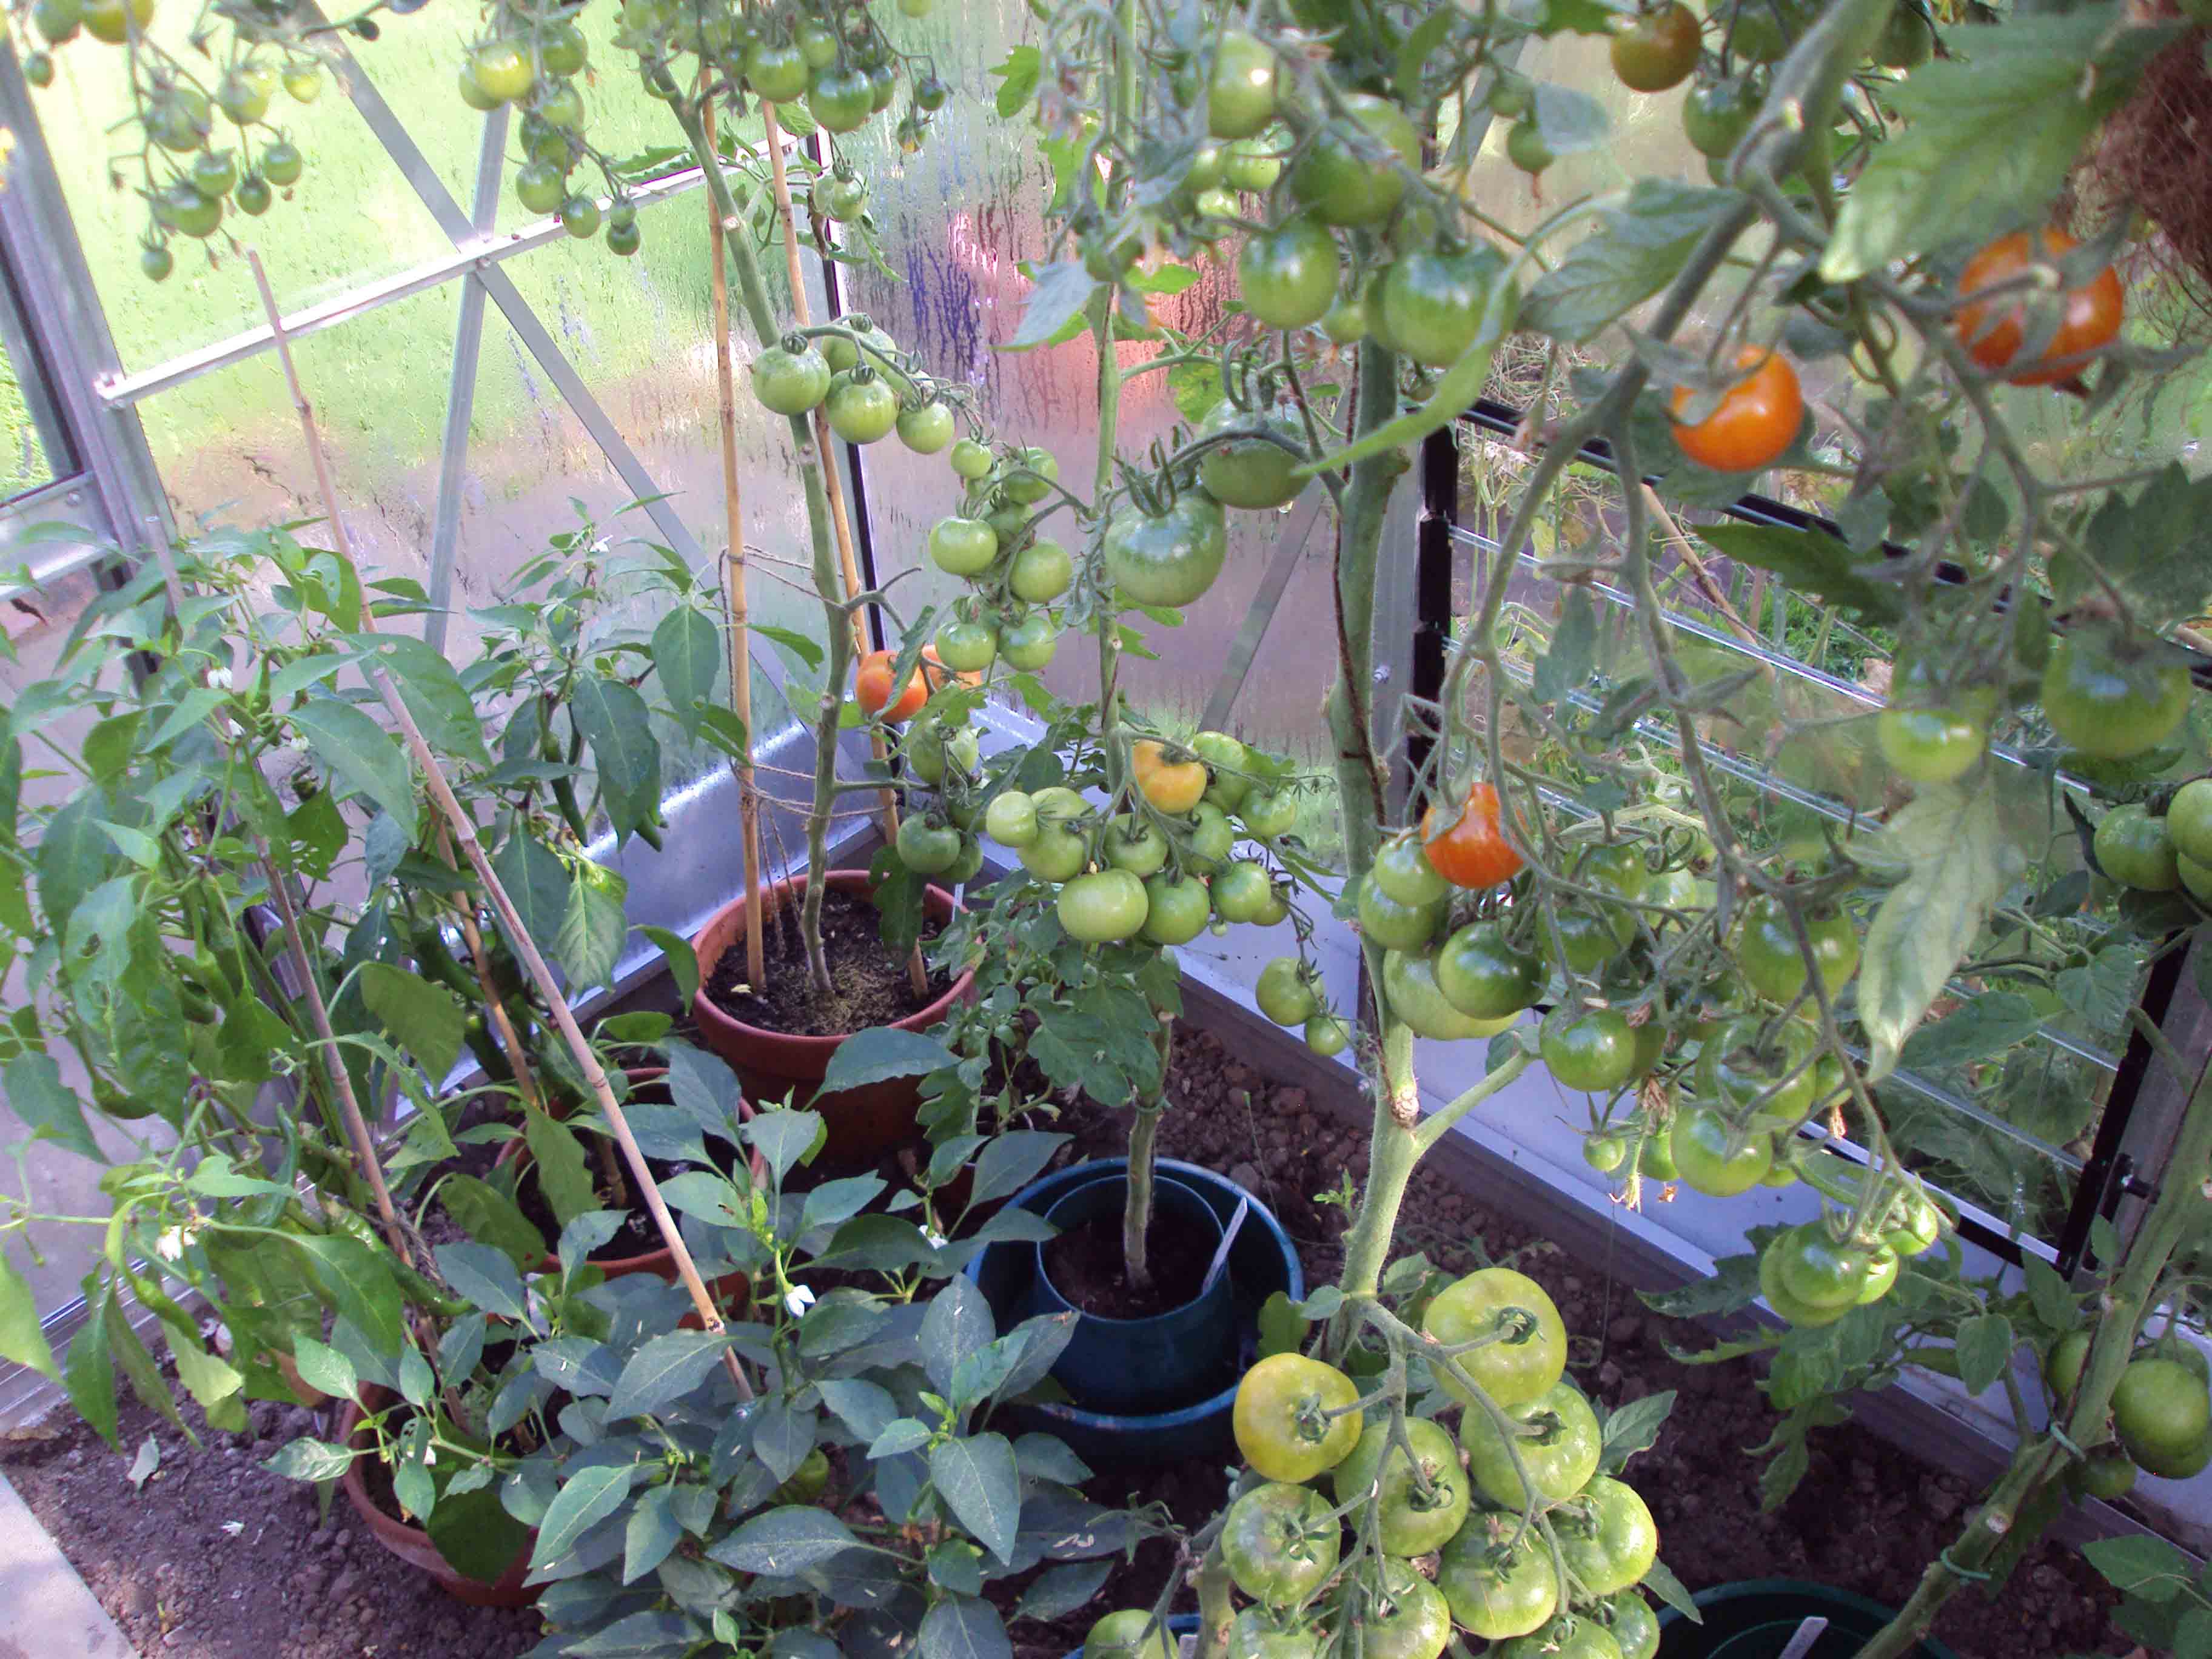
(706, 887, 953, 1037)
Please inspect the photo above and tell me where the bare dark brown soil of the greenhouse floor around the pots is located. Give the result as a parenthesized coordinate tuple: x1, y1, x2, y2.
(0, 1028, 2130, 1659)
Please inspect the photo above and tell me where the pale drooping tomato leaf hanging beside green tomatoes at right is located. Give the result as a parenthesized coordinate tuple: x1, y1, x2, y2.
(1858, 785, 2017, 1082)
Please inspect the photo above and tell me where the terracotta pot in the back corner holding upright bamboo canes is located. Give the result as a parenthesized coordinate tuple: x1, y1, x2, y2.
(692, 870, 976, 1157)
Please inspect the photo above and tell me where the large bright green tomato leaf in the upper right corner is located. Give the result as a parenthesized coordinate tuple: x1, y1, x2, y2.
(1820, 4, 2172, 283)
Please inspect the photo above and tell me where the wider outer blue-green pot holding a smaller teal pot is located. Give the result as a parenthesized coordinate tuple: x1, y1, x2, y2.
(967, 1157, 1305, 1464)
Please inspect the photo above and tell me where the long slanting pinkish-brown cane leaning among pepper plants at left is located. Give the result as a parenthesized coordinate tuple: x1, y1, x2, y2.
(246, 248, 752, 1400)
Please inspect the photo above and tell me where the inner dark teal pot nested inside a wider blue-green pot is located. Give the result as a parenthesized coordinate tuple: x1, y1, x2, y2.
(1028, 1175, 1252, 1411)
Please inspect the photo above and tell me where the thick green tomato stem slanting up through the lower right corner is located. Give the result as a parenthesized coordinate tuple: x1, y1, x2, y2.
(1858, 1048, 2212, 1659)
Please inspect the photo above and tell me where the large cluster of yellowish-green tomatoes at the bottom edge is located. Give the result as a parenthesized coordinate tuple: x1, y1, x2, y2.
(1203, 1267, 1659, 1659)
